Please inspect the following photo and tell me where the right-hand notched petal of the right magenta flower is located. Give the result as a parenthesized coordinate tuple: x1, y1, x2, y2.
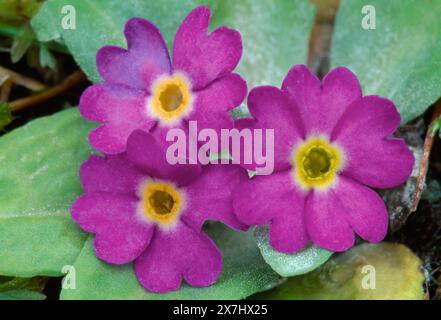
(332, 96, 414, 188)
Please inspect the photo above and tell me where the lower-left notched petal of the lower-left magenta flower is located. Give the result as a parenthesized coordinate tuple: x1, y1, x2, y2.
(71, 192, 154, 264)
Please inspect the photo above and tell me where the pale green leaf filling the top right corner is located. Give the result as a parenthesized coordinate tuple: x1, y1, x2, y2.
(331, 0, 441, 123)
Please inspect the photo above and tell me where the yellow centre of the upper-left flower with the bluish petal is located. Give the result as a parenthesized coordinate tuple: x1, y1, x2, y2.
(149, 74, 193, 123)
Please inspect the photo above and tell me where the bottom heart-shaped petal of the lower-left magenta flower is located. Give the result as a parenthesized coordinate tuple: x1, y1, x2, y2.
(135, 223, 222, 293)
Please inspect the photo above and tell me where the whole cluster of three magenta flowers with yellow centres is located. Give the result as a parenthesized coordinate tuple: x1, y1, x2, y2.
(71, 7, 413, 292)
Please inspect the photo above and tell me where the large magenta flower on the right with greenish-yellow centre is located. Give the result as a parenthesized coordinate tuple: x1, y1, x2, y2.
(233, 65, 413, 253)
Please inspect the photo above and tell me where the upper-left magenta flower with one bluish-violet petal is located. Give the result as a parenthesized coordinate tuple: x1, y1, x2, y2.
(80, 7, 247, 154)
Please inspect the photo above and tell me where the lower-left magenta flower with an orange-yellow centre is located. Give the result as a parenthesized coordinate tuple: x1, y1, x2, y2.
(71, 130, 247, 292)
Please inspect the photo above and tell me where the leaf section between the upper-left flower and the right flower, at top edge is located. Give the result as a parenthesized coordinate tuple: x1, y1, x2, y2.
(213, 0, 313, 88)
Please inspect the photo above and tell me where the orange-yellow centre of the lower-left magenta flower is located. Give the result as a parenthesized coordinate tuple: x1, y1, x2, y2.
(139, 181, 183, 227)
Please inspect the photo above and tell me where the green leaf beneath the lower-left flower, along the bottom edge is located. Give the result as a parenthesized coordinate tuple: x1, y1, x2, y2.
(61, 223, 279, 300)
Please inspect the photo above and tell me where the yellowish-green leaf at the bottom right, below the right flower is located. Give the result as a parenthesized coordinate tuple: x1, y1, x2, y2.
(255, 243, 424, 300)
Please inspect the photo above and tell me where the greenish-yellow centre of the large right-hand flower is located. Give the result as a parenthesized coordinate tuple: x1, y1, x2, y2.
(293, 137, 343, 189)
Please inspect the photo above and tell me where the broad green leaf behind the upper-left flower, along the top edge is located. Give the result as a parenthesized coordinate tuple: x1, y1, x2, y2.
(32, 0, 313, 86)
